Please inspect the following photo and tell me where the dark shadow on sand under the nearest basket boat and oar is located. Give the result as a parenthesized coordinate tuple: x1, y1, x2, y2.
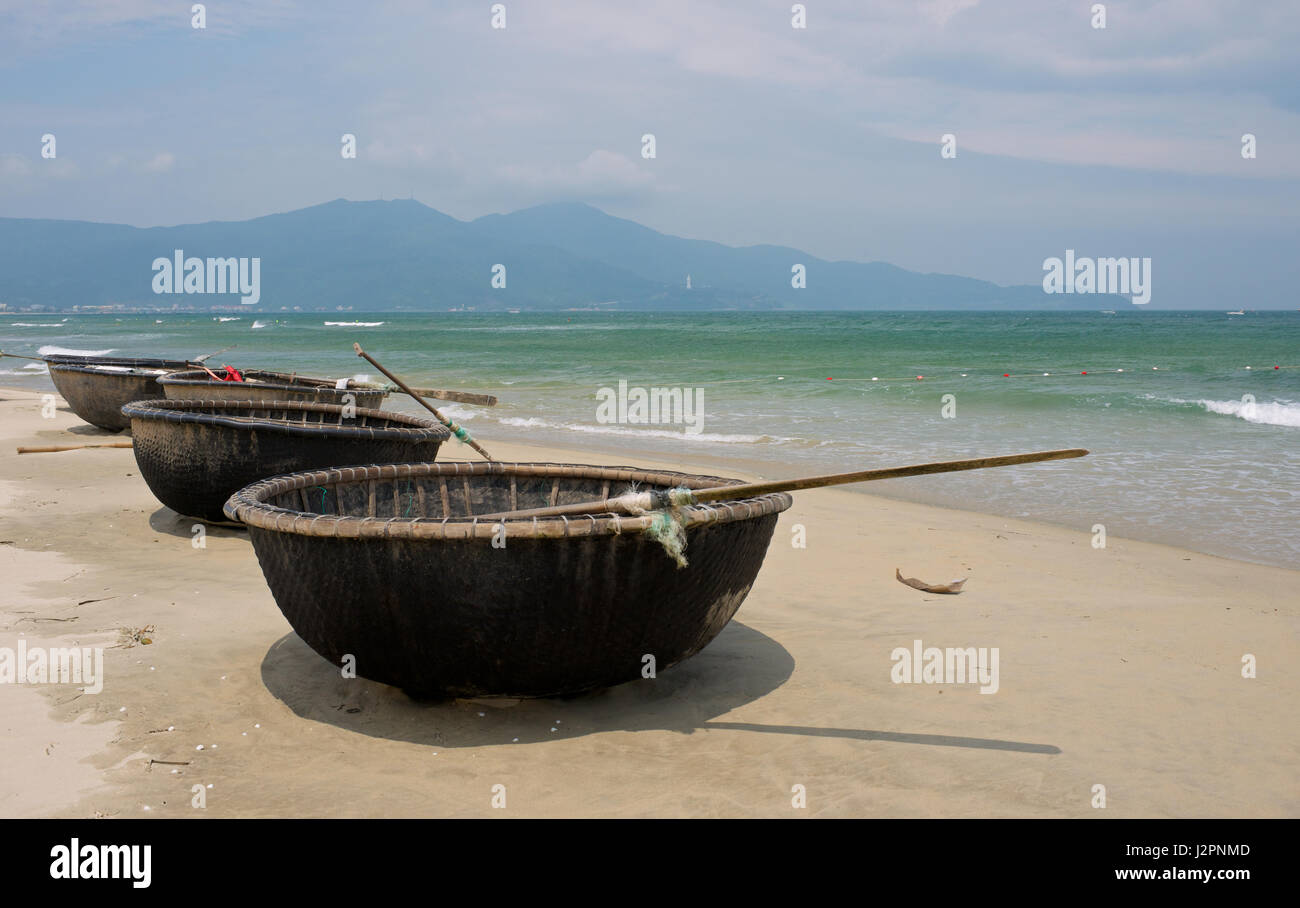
(261, 621, 1061, 754)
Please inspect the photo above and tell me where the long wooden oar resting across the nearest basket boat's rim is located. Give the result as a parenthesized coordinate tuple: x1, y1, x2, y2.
(475, 447, 1088, 520)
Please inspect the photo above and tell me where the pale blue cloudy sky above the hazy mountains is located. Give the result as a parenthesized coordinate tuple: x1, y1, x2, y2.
(0, 0, 1300, 308)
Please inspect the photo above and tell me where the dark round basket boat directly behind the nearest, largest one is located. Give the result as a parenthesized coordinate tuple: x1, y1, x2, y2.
(122, 401, 451, 522)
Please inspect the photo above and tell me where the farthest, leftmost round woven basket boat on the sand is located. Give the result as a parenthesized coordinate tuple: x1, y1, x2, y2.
(46, 355, 190, 432)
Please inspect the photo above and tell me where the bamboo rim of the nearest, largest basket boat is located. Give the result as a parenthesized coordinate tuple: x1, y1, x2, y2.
(224, 461, 794, 540)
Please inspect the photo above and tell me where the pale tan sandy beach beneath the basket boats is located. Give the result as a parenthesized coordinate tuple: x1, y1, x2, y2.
(0, 389, 1300, 817)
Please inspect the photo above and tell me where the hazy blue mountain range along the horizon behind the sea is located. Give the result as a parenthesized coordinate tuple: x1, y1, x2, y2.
(0, 199, 1123, 310)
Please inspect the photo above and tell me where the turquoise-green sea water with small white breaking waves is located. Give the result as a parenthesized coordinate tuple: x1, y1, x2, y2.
(0, 310, 1300, 567)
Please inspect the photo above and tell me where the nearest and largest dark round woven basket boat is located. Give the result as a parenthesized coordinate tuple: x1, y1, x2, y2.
(226, 463, 790, 697)
